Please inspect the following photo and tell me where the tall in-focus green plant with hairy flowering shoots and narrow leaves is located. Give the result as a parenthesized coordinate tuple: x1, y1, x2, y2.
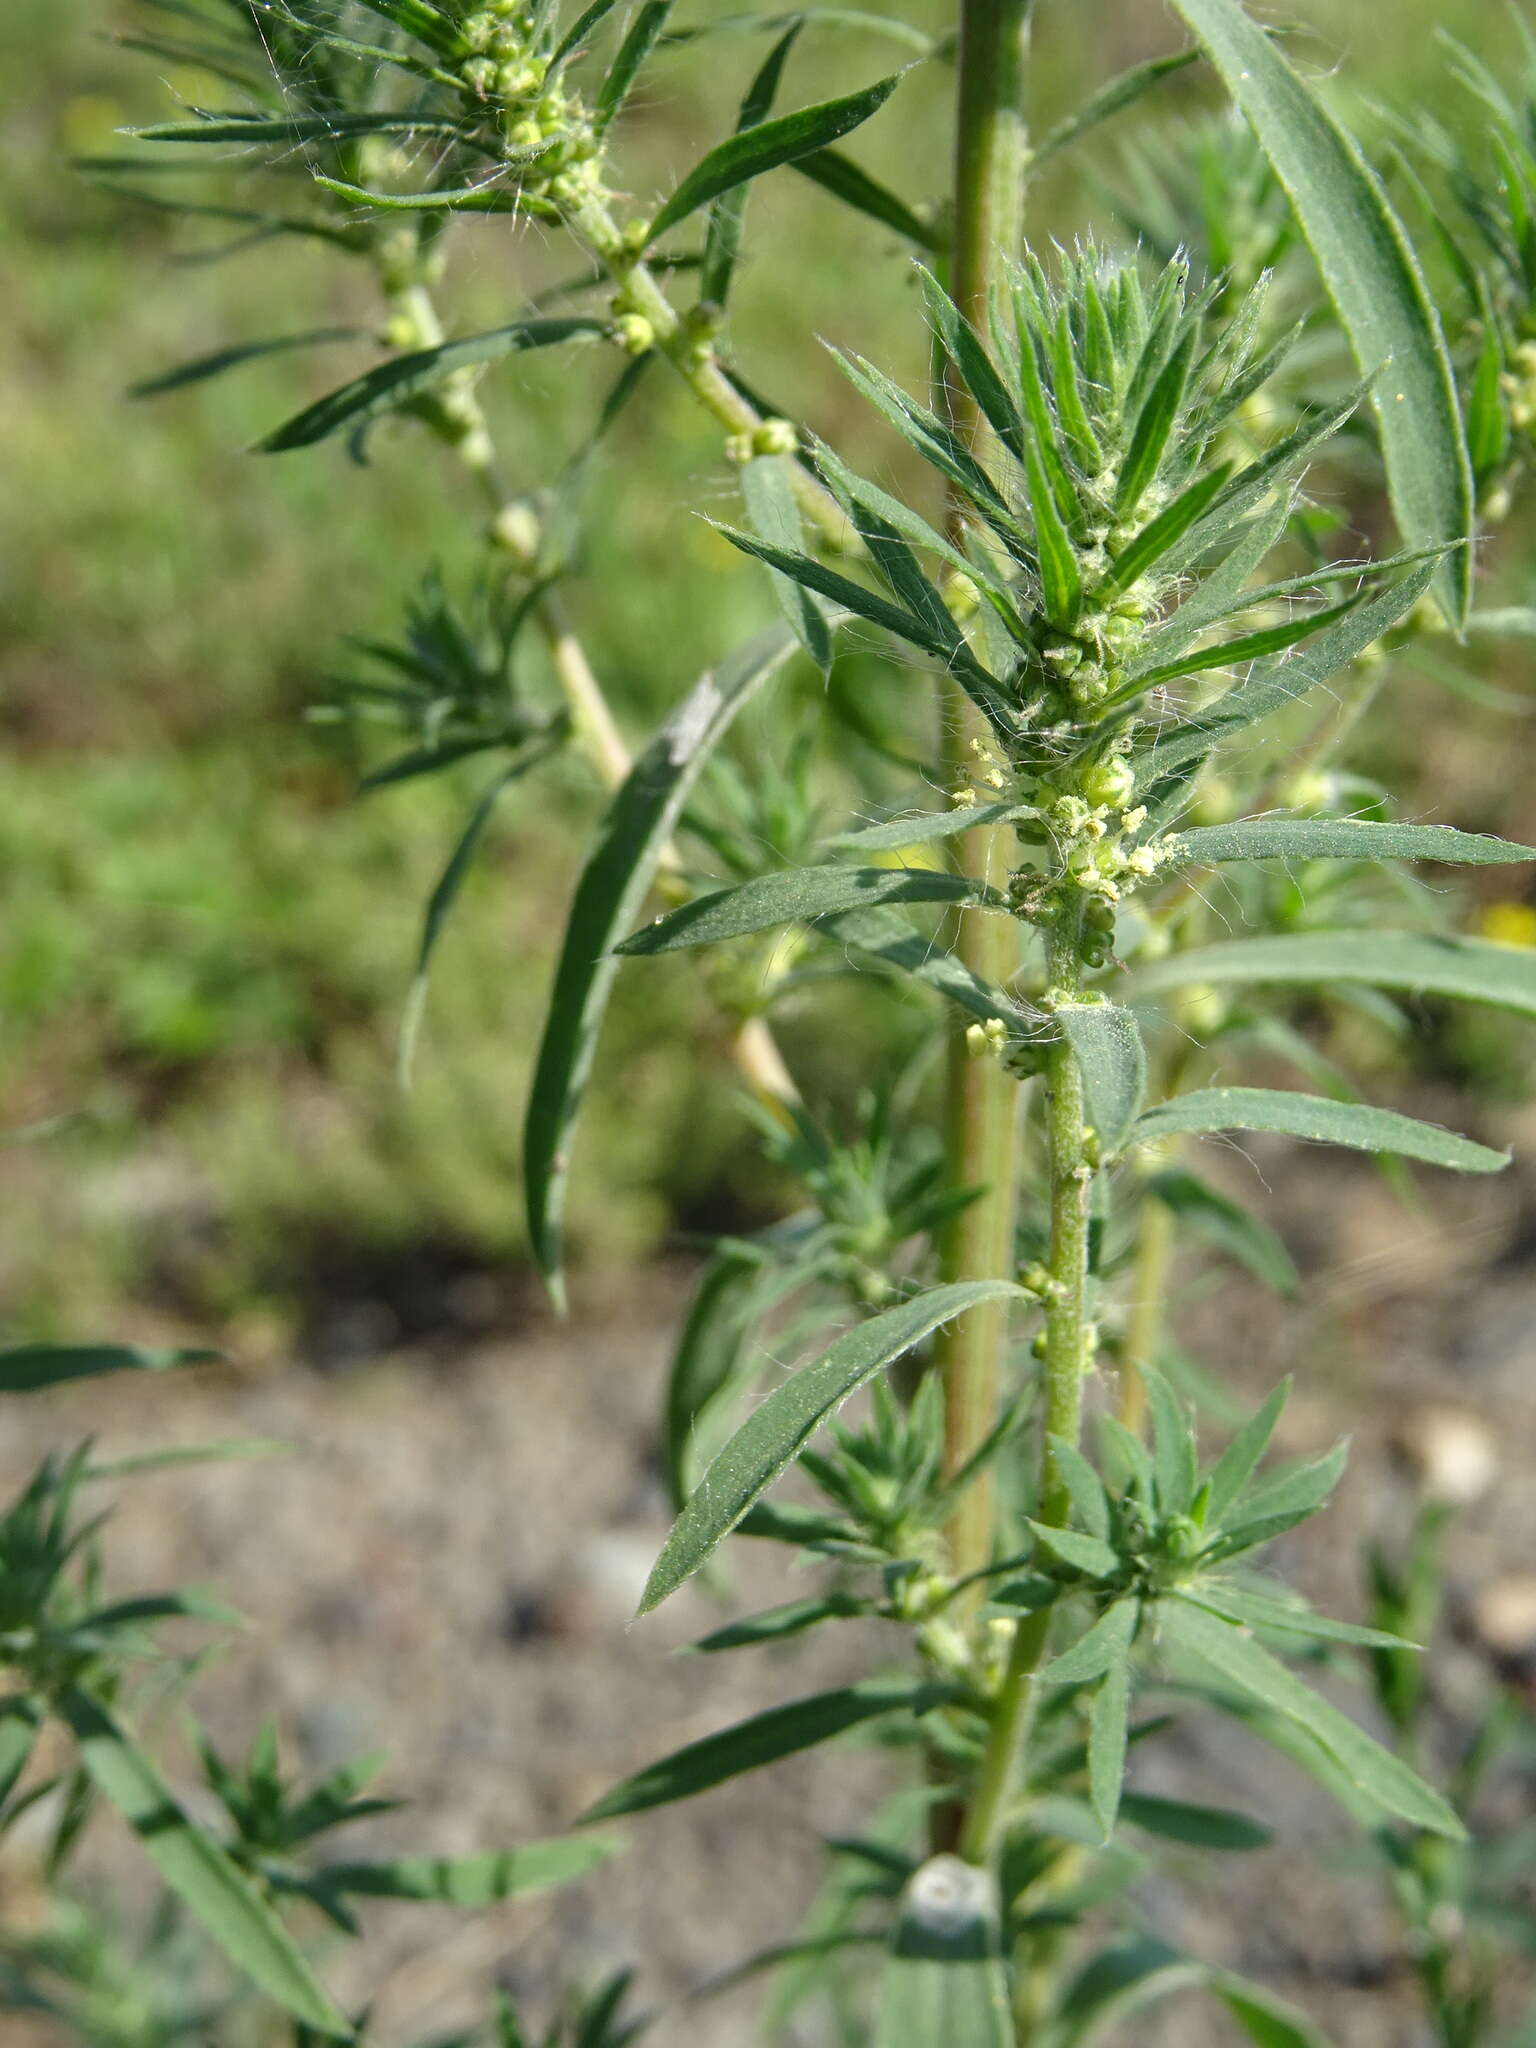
(63, 0, 1536, 2048)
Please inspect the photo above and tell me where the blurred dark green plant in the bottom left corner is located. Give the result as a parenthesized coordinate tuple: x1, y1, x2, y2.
(0, 1346, 631, 2048)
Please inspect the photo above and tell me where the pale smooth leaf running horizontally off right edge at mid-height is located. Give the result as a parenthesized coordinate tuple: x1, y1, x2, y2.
(1135, 932, 1536, 1016)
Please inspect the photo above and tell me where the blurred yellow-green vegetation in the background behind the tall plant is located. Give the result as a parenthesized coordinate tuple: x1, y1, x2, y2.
(0, 0, 1536, 1360)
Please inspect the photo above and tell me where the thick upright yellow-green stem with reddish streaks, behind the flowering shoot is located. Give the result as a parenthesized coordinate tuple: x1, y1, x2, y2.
(938, 0, 1030, 1573)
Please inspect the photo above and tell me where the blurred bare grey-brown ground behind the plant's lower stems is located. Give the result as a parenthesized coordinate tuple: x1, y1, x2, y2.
(0, 1128, 1536, 2048)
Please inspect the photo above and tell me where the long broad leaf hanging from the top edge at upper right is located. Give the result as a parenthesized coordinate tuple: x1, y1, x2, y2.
(1174, 0, 1473, 625)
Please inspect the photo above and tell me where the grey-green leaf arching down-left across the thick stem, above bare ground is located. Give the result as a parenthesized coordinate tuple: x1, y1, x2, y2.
(639, 1280, 1020, 1614)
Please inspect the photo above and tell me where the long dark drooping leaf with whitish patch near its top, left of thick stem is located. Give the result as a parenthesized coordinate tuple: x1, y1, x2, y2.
(522, 627, 811, 1305)
